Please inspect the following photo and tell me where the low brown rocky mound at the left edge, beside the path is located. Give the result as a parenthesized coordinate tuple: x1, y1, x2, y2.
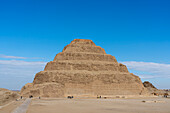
(0, 88, 19, 106)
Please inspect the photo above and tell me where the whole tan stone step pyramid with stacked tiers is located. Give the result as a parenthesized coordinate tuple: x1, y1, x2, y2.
(21, 39, 146, 97)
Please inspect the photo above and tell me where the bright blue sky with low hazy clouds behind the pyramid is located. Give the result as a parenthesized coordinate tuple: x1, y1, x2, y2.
(0, 0, 170, 89)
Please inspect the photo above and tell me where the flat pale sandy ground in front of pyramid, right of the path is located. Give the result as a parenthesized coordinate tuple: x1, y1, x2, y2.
(27, 98, 170, 113)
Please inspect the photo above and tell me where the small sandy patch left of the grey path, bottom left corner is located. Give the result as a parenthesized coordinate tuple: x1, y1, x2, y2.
(0, 100, 24, 113)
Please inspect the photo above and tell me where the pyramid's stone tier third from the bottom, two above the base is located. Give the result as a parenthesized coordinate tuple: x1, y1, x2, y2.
(44, 60, 128, 73)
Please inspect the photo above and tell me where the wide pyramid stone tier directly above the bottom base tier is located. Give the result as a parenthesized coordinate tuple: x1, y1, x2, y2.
(33, 70, 139, 84)
